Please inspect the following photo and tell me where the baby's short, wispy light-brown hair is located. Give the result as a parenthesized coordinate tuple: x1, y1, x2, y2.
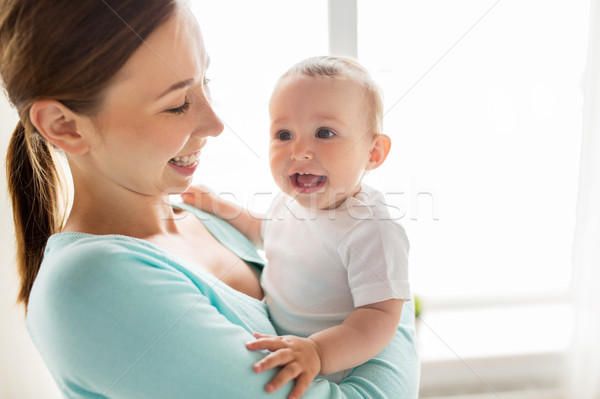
(280, 55, 383, 134)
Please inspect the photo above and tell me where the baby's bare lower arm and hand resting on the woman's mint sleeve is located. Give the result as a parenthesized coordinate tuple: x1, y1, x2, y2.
(246, 299, 404, 398)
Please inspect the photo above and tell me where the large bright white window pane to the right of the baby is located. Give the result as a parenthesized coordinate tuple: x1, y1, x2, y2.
(358, 0, 589, 297)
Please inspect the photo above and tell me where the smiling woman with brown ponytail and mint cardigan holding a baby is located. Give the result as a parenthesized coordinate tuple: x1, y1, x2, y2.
(0, 0, 418, 398)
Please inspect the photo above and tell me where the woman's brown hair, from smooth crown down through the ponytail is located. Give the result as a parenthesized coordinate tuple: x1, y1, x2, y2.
(0, 0, 177, 307)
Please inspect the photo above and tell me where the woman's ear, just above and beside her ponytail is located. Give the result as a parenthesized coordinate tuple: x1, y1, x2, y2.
(29, 100, 89, 155)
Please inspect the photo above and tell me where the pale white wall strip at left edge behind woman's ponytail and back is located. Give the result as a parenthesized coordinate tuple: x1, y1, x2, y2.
(0, 96, 61, 399)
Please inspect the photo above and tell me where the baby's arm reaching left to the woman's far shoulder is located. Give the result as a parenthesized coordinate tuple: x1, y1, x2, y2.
(181, 185, 263, 247)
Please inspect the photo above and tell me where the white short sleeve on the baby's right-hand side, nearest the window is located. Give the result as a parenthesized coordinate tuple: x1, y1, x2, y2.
(338, 218, 411, 307)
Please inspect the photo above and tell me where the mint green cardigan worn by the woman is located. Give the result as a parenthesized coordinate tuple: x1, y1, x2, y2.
(27, 205, 419, 399)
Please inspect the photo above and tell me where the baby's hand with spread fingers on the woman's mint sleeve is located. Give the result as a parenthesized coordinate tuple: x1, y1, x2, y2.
(246, 333, 321, 399)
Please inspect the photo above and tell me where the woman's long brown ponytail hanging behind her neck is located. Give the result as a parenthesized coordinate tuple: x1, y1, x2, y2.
(6, 121, 64, 308)
